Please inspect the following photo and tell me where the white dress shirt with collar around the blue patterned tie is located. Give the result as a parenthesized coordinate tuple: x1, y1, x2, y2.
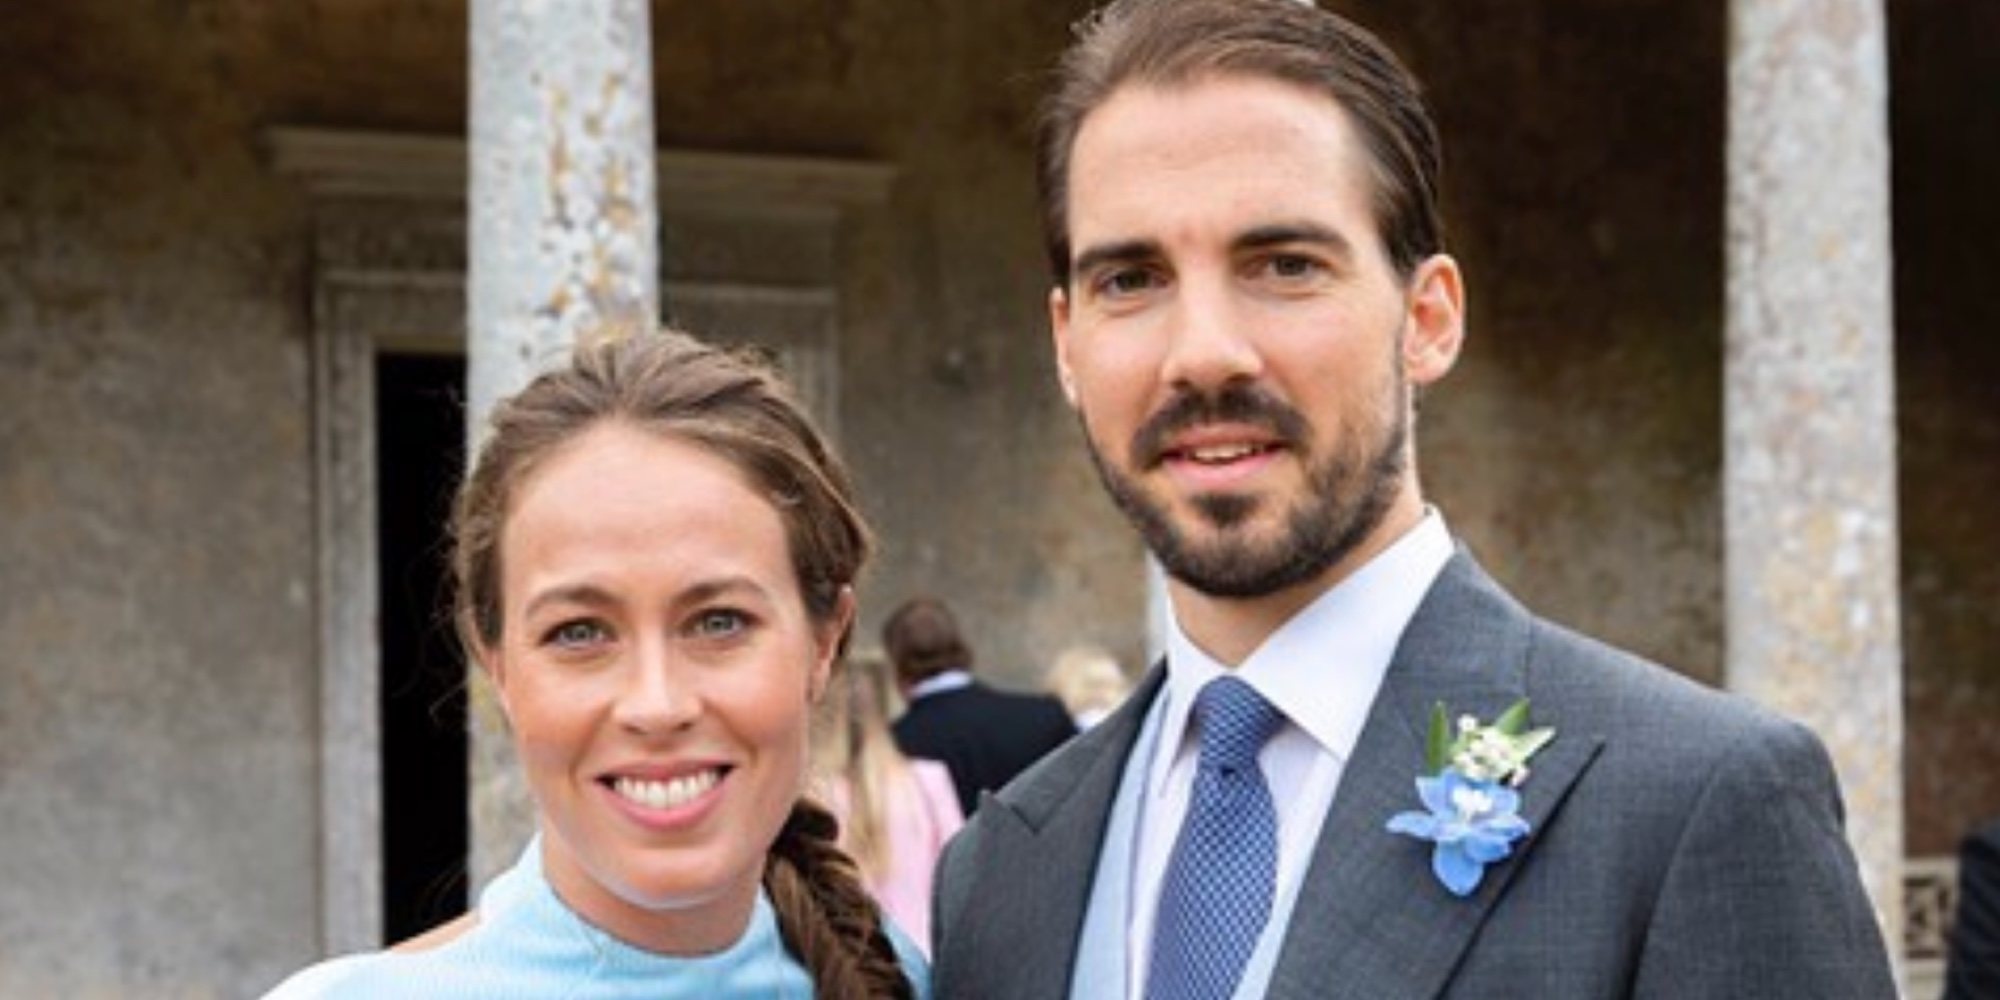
(1126, 508, 1452, 1000)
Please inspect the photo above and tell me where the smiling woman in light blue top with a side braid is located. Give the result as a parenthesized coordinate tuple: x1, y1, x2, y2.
(274, 332, 928, 1000)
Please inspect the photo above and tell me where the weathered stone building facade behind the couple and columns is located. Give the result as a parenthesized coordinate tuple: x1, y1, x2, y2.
(0, 0, 2000, 996)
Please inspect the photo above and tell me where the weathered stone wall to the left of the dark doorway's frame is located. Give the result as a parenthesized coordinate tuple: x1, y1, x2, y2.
(0, 0, 464, 998)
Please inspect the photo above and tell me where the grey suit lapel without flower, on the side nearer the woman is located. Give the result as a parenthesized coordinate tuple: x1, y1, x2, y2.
(966, 666, 1166, 996)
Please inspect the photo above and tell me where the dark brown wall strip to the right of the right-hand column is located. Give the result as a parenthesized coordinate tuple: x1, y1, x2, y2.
(1888, 0, 2000, 854)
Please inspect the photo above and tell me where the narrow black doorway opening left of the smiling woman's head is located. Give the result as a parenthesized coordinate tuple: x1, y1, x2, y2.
(376, 354, 468, 942)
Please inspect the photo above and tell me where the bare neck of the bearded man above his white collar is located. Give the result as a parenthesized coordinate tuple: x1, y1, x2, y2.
(1166, 496, 1424, 666)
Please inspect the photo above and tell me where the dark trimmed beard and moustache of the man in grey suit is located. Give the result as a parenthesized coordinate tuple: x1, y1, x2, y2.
(1084, 376, 1410, 598)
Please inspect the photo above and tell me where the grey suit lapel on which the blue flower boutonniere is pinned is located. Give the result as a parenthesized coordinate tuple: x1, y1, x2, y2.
(1268, 552, 1602, 1000)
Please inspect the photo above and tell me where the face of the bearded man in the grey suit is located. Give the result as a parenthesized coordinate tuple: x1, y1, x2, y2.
(1050, 76, 1460, 598)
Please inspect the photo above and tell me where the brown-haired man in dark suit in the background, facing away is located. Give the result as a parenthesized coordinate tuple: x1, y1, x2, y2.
(882, 598, 1076, 816)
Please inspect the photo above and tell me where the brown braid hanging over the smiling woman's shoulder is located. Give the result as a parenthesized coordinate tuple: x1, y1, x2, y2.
(764, 798, 914, 1000)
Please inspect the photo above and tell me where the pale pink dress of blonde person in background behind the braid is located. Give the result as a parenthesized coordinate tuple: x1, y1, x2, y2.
(828, 760, 966, 958)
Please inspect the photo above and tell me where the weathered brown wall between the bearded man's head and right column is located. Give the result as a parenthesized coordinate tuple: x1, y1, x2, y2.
(1368, 0, 1724, 682)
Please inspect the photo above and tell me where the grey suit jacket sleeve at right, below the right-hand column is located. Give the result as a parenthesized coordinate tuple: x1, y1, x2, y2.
(1634, 720, 1896, 1000)
